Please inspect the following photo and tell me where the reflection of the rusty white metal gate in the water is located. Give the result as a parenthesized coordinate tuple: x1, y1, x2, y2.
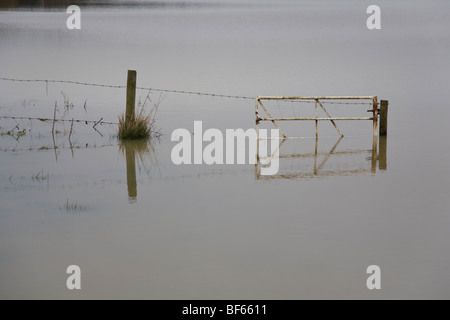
(255, 136, 387, 180)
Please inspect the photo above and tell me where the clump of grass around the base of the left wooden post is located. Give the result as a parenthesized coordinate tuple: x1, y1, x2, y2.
(119, 93, 160, 140)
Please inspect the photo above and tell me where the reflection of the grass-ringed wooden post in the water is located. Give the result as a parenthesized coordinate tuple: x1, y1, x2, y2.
(119, 140, 153, 203)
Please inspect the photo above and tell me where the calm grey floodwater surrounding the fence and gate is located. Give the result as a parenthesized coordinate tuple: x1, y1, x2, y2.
(0, 0, 450, 299)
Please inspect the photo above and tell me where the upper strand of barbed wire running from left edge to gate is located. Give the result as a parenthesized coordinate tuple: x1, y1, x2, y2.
(0, 77, 378, 105)
